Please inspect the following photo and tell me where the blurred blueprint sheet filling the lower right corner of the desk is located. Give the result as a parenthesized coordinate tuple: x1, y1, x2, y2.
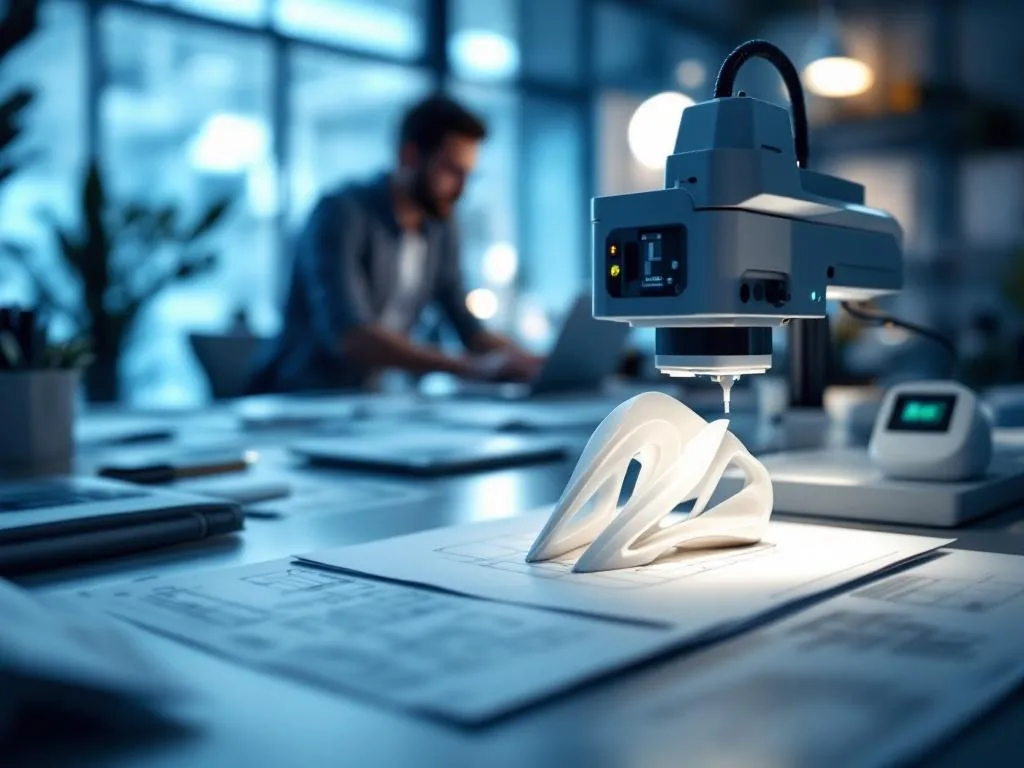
(597, 552, 1024, 768)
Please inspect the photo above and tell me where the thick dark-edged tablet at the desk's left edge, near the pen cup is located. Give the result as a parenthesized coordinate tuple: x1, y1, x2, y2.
(0, 477, 243, 574)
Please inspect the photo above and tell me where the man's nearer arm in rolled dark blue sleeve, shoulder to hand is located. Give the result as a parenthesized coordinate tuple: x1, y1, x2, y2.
(298, 196, 475, 377)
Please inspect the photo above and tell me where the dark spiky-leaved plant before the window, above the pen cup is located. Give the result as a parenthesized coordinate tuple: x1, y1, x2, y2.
(6, 162, 230, 401)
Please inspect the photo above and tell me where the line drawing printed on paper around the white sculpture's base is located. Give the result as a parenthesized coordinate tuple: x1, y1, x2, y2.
(434, 535, 775, 590)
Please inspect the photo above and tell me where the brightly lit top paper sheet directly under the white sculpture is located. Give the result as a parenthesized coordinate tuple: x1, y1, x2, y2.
(301, 509, 949, 639)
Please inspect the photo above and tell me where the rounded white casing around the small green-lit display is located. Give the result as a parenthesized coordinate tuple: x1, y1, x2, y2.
(868, 381, 992, 482)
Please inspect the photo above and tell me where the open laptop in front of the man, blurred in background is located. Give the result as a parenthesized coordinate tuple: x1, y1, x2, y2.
(457, 294, 630, 399)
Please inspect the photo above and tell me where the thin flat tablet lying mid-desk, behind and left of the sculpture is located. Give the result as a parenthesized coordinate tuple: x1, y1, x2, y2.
(290, 430, 566, 475)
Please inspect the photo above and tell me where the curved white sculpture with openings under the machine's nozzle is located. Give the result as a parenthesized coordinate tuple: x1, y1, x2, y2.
(526, 392, 772, 572)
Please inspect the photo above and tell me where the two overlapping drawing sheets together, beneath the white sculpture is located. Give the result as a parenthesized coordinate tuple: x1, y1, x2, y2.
(75, 516, 944, 723)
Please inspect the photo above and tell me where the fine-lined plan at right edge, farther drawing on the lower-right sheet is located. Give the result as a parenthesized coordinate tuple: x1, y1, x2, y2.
(853, 573, 1024, 613)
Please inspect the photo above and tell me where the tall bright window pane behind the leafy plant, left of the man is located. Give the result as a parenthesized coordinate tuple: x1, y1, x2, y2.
(100, 7, 278, 404)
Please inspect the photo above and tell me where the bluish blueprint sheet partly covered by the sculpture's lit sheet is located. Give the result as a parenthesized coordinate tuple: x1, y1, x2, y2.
(68, 560, 671, 724)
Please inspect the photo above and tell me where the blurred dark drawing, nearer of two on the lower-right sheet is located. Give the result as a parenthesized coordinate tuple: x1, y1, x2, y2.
(788, 610, 985, 662)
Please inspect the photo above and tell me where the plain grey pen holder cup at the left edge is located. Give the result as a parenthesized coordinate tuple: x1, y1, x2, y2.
(0, 369, 79, 477)
